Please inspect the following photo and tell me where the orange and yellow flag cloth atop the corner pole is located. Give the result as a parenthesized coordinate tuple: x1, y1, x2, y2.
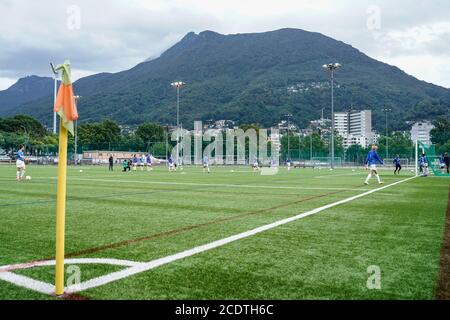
(54, 60, 78, 135)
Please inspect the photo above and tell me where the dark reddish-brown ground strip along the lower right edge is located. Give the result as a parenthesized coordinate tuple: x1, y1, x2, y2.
(435, 186, 450, 300)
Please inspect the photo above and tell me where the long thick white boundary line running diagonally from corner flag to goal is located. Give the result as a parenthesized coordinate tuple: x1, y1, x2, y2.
(66, 177, 416, 294)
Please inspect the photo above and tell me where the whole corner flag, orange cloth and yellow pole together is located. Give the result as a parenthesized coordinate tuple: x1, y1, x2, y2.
(54, 60, 78, 295)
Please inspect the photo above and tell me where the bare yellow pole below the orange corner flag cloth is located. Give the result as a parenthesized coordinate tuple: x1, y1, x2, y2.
(55, 121, 67, 296)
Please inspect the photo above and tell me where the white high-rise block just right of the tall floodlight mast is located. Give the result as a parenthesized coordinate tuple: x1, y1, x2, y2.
(334, 110, 373, 148)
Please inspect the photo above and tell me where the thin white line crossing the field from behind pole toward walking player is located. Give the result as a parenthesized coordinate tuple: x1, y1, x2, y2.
(49, 177, 370, 191)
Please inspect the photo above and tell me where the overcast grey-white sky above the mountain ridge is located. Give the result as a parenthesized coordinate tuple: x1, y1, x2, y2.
(0, 0, 450, 90)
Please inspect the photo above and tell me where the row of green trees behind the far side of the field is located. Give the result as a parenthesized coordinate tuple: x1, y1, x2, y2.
(0, 115, 450, 163)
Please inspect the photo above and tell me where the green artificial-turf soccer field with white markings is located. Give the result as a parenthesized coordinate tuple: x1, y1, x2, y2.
(0, 166, 449, 299)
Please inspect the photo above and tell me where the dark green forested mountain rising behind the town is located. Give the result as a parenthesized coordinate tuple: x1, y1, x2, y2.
(0, 29, 450, 129)
